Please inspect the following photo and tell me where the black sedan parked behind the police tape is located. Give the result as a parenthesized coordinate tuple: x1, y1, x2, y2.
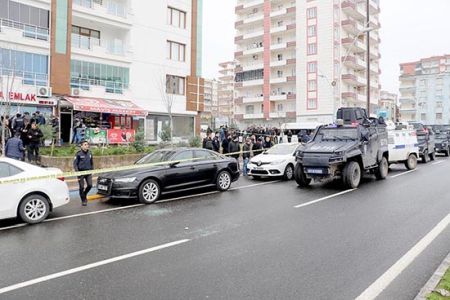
(97, 148, 239, 204)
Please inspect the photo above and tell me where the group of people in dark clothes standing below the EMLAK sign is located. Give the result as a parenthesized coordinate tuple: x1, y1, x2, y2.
(0, 111, 59, 164)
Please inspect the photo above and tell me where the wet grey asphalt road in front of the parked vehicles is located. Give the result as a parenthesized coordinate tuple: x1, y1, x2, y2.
(0, 158, 450, 300)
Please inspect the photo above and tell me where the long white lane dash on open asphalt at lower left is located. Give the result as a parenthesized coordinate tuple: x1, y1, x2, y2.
(0, 239, 190, 295)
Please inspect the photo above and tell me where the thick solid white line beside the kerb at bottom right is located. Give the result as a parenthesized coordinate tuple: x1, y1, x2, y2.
(356, 214, 450, 300)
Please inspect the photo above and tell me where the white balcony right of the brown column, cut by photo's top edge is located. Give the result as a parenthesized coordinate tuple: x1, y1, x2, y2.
(73, 0, 132, 29)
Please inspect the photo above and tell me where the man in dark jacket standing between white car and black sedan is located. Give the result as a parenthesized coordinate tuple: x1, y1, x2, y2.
(73, 140, 94, 206)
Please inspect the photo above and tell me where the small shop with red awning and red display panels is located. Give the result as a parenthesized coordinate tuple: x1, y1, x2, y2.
(59, 97, 147, 144)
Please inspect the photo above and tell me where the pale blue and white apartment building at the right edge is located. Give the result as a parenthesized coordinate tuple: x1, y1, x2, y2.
(400, 55, 450, 125)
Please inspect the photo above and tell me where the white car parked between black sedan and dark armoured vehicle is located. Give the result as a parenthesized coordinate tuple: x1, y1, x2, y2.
(248, 143, 302, 180)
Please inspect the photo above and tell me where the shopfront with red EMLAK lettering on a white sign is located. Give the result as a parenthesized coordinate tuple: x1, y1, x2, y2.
(0, 91, 57, 120)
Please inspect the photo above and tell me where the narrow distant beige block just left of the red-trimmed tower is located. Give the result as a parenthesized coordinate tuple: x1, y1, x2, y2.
(216, 61, 236, 126)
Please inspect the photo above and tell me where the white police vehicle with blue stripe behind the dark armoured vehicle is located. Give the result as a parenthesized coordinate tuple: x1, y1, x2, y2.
(388, 128, 419, 170)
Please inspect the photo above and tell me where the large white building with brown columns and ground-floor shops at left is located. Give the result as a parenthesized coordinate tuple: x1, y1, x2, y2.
(0, 0, 204, 142)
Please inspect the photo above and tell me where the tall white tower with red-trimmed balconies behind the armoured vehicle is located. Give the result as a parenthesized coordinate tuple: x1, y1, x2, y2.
(235, 0, 380, 126)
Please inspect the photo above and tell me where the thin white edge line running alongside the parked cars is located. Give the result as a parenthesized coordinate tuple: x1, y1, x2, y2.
(0, 181, 280, 231)
